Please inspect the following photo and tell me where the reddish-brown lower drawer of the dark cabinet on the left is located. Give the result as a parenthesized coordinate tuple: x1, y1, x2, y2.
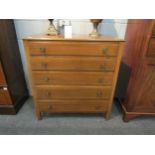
(0, 86, 12, 105)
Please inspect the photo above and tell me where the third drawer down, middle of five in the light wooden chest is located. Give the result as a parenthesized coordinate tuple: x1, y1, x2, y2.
(33, 71, 114, 86)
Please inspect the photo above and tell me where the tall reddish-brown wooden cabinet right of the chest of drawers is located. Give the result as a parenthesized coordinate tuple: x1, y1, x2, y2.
(117, 20, 155, 121)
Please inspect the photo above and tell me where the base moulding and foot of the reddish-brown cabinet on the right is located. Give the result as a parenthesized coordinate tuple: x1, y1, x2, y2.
(117, 98, 155, 122)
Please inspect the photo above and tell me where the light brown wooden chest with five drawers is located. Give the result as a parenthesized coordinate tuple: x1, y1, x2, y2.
(23, 36, 123, 119)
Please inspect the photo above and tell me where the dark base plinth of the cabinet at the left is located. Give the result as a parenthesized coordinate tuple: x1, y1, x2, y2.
(0, 96, 29, 115)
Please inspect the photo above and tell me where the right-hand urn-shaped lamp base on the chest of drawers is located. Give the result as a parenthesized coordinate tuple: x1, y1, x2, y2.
(90, 19, 102, 37)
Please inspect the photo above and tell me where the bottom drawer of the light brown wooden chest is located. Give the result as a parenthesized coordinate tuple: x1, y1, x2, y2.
(37, 100, 108, 112)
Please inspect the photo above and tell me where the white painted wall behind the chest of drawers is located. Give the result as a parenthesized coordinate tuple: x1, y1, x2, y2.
(14, 19, 127, 92)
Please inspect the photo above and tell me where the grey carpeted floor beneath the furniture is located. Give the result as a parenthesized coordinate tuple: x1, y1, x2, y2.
(0, 98, 155, 135)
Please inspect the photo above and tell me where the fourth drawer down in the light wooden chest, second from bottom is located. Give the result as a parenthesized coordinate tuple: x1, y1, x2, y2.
(36, 86, 111, 100)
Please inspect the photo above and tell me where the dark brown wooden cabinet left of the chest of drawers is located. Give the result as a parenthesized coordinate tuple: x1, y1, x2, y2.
(0, 19, 28, 114)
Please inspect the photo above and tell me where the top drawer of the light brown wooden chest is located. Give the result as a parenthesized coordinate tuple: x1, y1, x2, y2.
(29, 41, 118, 57)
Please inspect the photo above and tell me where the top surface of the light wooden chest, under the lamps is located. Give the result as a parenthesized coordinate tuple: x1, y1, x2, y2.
(23, 34, 124, 42)
